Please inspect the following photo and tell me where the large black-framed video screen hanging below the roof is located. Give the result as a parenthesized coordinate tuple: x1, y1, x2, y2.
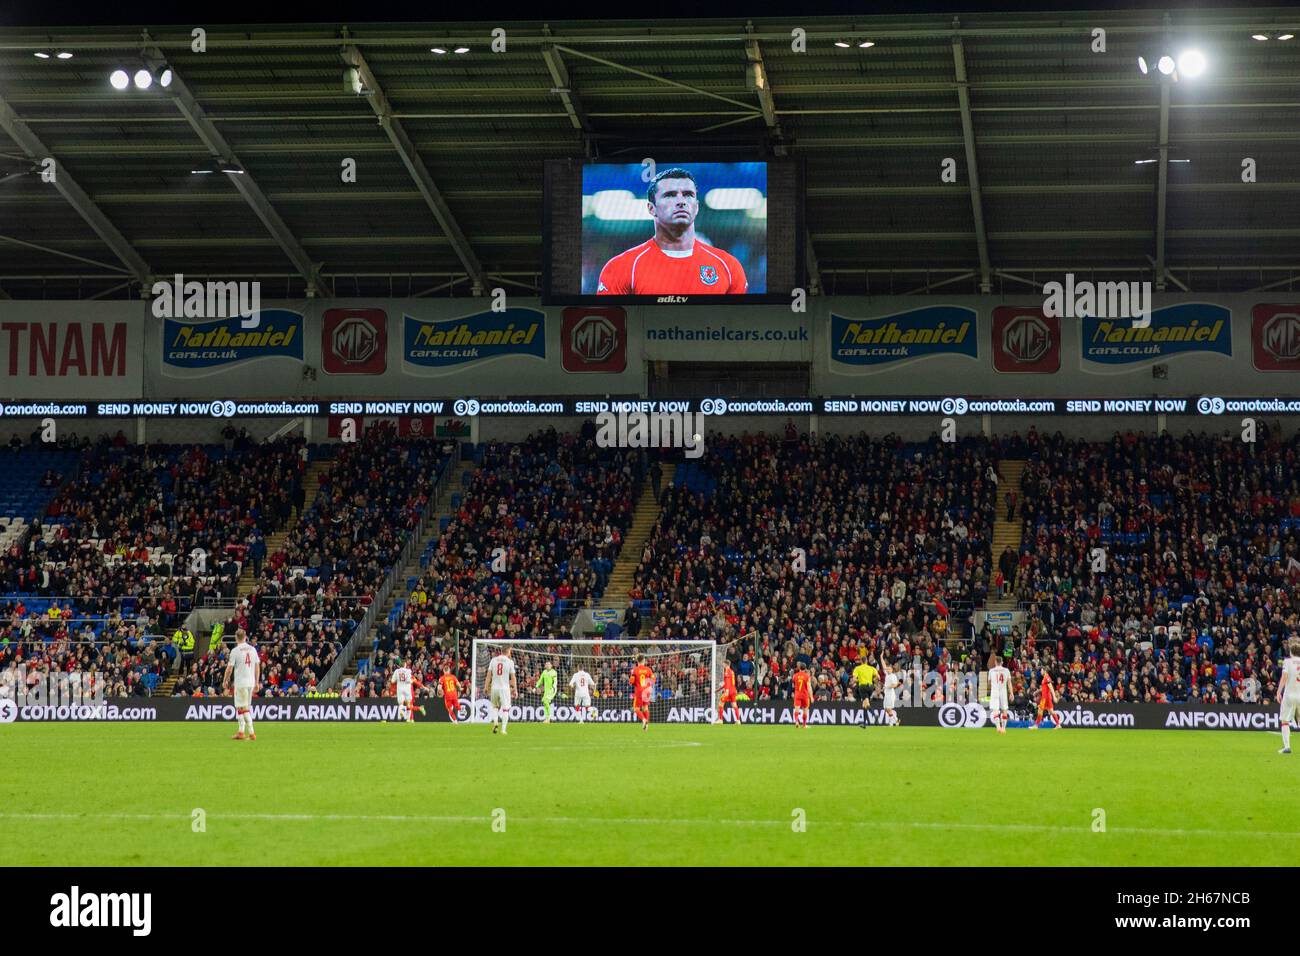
(545, 160, 803, 304)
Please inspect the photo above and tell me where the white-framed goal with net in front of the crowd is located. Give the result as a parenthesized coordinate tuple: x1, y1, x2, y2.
(471, 637, 724, 723)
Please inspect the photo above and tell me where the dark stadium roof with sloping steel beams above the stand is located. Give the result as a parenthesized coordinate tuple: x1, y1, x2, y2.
(0, 8, 1300, 299)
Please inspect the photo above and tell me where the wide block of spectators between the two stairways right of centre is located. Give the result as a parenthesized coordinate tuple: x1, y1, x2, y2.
(631, 434, 1001, 700)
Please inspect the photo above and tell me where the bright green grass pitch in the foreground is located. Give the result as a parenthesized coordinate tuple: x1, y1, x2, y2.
(0, 722, 1300, 866)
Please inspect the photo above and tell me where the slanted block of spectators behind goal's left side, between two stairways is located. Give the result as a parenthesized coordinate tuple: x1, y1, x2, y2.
(356, 429, 646, 696)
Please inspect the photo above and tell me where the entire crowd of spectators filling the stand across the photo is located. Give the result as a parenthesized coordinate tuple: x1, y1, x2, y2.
(0, 427, 1300, 704)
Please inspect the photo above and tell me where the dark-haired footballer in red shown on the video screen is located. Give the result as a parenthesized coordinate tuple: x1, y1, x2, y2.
(595, 166, 749, 295)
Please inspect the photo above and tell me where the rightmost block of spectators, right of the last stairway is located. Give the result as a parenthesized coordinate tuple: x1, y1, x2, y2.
(976, 431, 1300, 704)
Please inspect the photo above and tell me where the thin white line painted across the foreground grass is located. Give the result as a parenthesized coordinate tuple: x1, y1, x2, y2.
(0, 812, 1296, 839)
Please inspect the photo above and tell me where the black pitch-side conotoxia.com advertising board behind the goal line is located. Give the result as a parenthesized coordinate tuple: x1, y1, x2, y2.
(0, 697, 1279, 731)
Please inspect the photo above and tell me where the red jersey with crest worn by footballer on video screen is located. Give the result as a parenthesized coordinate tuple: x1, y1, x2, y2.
(595, 237, 749, 295)
